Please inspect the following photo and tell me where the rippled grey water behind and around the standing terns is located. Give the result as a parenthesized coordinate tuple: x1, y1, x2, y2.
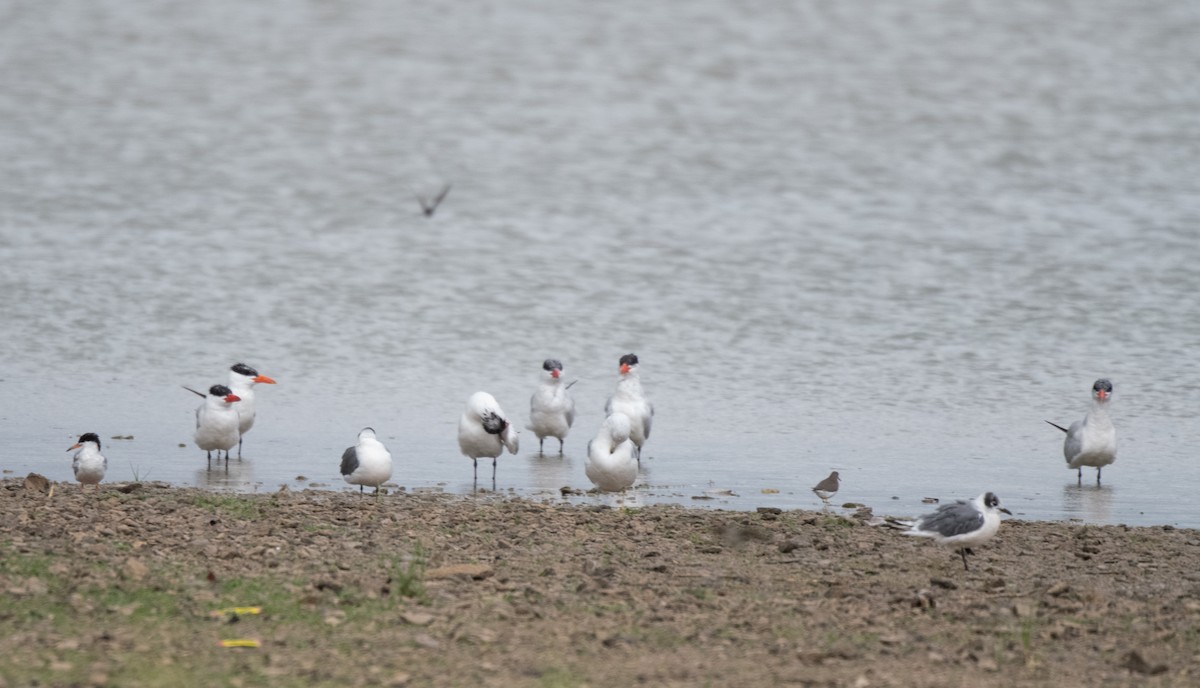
(0, 0, 1200, 527)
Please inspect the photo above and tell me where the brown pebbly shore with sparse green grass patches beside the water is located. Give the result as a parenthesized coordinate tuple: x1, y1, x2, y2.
(0, 478, 1200, 687)
